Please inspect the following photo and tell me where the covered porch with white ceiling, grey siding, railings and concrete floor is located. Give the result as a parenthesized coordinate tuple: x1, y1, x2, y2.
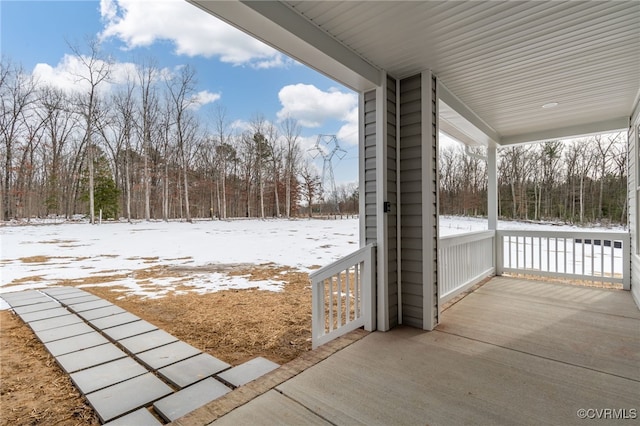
(177, 0, 640, 425)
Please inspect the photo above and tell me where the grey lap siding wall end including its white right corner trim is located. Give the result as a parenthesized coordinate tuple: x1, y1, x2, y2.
(399, 74, 438, 329)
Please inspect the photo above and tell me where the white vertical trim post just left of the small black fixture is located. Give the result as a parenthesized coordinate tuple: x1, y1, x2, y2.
(376, 73, 389, 331)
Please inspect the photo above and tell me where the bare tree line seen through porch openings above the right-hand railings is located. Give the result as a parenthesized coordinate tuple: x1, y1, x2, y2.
(439, 133, 627, 224)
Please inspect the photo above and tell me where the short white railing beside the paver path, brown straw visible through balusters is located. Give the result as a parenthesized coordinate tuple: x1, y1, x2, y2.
(309, 244, 376, 349)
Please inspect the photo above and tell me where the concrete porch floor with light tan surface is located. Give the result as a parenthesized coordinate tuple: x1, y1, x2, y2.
(175, 277, 640, 425)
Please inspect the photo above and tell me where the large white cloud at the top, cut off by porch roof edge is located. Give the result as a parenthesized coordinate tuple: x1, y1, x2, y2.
(100, 0, 292, 68)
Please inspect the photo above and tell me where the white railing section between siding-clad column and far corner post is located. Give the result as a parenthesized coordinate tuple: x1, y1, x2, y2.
(438, 231, 495, 302)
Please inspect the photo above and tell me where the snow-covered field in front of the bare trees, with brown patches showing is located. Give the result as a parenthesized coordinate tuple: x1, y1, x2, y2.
(0, 216, 620, 310)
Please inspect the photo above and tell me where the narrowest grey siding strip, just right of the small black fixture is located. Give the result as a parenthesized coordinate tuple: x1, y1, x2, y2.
(385, 77, 398, 327)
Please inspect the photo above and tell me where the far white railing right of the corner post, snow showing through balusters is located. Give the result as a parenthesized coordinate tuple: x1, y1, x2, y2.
(496, 230, 631, 290)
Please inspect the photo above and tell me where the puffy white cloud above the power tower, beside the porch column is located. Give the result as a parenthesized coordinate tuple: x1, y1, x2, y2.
(277, 84, 358, 145)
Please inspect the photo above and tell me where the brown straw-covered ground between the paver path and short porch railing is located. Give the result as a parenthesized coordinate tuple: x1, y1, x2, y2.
(83, 265, 311, 365)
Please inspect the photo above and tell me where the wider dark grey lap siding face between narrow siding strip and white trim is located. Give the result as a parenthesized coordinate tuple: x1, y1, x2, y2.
(398, 75, 423, 328)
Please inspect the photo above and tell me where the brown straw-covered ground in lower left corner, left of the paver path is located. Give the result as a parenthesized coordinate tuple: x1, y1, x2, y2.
(0, 311, 100, 426)
